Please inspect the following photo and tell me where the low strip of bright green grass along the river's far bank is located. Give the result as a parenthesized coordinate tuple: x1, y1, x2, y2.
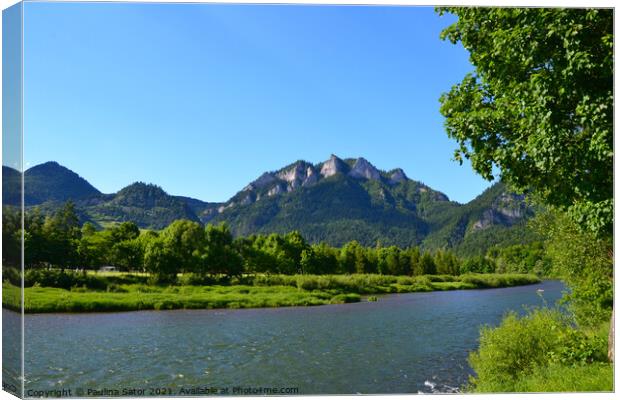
(2, 274, 540, 313)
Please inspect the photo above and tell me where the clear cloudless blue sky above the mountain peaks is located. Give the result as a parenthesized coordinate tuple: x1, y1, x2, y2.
(24, 3, 489, 202)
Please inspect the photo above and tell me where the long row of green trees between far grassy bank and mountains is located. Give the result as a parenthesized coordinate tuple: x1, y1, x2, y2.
(3, 202, 547, 282)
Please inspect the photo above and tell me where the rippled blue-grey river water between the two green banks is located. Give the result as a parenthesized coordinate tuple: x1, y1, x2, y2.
(8, 281, 563, 394)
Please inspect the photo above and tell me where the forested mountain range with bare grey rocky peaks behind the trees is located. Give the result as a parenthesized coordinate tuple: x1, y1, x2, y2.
(2, 155, 533, 254)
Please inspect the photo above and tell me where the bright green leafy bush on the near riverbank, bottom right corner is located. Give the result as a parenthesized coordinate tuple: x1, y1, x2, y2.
(469, 309, 613, 392)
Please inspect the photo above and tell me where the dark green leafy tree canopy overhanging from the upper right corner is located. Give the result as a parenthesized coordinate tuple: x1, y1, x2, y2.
(438, 7, 613, 235)
